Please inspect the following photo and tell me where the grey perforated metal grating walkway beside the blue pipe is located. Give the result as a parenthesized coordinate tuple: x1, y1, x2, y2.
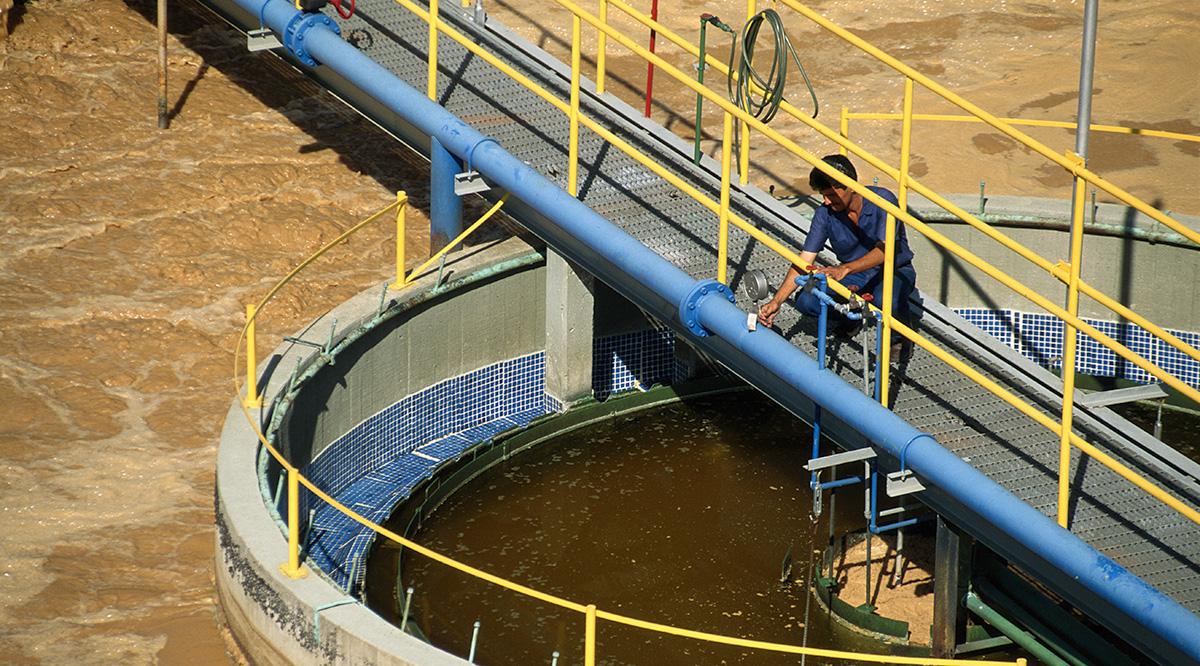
(331, 0, 1200, 612)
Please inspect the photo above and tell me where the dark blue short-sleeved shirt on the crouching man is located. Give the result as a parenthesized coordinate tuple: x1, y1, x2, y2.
(804, 185, 912, 272)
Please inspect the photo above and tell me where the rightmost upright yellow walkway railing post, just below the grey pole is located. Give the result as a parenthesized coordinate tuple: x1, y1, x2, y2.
(1058, 157, 1087, 529)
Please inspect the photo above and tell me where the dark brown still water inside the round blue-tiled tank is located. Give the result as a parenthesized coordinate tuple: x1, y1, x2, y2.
(379, 392, 902, 665)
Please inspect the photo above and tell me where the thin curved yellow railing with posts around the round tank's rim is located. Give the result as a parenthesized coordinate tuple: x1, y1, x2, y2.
(233, 199, 1026, 666)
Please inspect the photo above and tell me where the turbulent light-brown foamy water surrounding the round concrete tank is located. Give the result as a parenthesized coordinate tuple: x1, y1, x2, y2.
(0, 0, 1200, 664)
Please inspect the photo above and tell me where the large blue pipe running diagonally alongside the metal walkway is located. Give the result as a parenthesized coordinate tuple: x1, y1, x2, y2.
(236, 0, 1200, 661)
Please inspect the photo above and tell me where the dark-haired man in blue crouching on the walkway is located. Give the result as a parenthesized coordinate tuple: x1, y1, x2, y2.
(758, 155, 917, 332)
